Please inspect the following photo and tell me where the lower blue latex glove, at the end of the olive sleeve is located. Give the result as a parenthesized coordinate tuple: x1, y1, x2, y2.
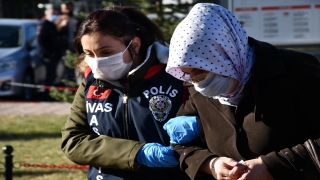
(137, 143, 179, 167)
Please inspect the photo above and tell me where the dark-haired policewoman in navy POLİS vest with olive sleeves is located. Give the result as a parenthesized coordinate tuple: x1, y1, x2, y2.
(61, 6, 189, 180)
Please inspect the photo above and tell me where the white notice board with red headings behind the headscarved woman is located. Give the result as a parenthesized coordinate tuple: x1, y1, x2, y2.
(233, 0, 320, 45)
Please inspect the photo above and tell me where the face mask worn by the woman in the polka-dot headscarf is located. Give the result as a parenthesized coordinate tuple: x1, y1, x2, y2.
(193, 72, 234, 97)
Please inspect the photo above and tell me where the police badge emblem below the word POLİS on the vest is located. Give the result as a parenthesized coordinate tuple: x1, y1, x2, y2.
(149, 95, 172, 122)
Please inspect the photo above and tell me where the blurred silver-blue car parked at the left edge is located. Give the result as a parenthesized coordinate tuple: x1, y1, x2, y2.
(0, 18, 40, 100)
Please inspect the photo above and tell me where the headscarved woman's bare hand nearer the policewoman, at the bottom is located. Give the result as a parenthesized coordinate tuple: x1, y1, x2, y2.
(211, 157, 247, 180)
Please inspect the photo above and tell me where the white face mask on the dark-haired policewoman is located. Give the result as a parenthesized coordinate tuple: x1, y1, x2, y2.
(86, 40, 133, 81)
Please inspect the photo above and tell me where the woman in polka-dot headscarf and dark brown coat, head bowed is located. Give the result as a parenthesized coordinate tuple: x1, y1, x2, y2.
(164, 3, 320, 180)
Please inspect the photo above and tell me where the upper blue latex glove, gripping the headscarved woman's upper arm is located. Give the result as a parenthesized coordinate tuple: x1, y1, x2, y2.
(163, 116, 200, 144)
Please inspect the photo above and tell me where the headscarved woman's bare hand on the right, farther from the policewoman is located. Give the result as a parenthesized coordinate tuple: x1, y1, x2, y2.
(230, 157, 273, 180)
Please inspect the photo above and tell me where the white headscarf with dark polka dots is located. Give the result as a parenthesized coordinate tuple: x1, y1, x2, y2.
(166, 3, 253, 105)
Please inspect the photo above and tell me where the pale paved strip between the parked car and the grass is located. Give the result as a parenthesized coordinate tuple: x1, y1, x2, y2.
(0, 101, 71, 116)
